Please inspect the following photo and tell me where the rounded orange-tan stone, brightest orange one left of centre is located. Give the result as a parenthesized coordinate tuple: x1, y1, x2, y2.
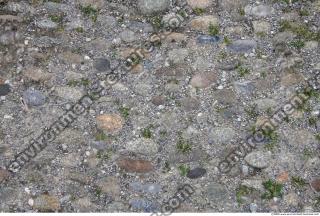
(96, 114, 124, 133)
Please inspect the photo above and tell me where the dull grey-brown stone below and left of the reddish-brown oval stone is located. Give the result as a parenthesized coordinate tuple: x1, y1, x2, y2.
(97, 176, 120, 197)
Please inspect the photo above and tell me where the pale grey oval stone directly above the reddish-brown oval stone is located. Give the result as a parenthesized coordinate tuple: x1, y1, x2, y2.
(125, 138, 158, 155)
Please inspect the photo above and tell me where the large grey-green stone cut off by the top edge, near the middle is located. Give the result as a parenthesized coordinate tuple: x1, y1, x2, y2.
(137, 0, 170, 15)
